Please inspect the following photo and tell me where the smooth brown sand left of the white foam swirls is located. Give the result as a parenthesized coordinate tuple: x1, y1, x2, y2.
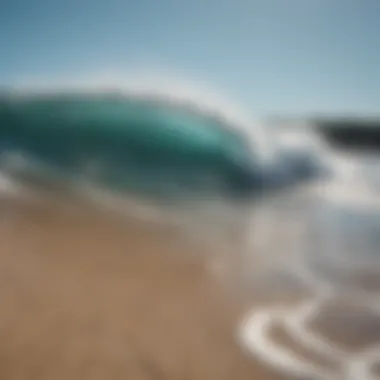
(0, 193, 288, 380)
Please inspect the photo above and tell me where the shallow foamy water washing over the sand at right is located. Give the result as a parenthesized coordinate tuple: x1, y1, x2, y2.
(240, 155, 380, 380)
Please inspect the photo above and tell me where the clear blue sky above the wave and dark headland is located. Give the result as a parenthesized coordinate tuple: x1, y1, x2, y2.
(0, 0, 380, 115)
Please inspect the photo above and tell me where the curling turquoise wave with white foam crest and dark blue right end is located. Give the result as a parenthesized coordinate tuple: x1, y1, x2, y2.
(1, 86, 336, 205)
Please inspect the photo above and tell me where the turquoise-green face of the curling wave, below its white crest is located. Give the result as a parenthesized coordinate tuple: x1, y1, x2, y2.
(0, 95, 264, 199)
